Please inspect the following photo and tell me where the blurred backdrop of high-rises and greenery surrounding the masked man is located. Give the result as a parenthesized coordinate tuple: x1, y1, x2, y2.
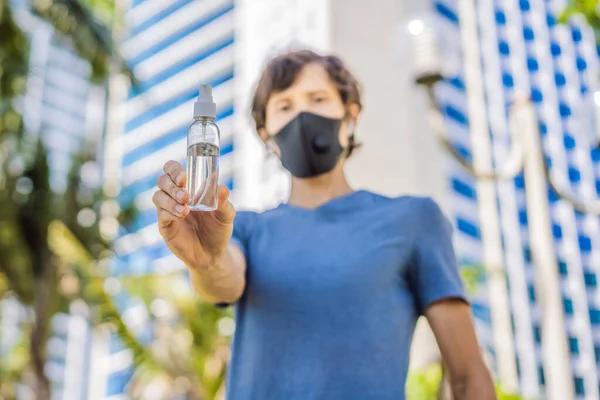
(0, 0, 600, 400)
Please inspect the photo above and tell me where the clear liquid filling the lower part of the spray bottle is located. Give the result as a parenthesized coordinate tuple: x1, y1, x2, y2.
(187, 142, 220, 211)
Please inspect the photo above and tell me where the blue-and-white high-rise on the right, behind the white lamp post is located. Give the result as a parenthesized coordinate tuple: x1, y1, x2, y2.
(428, 0, 600, 399)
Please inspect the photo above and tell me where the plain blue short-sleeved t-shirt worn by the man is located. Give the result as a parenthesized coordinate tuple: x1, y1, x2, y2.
(227, 191, 465, 400)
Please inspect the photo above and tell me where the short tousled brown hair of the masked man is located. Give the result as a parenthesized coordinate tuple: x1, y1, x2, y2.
(252, 50, 362, 156)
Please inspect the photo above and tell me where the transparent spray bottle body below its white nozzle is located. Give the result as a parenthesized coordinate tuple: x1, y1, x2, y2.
(187, 117, 221, 211)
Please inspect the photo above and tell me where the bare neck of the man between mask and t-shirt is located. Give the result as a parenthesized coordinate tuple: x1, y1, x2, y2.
(288, 165, 354, 209)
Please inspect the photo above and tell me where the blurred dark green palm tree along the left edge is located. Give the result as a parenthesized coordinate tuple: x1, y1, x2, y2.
(0, 0, 142, 399)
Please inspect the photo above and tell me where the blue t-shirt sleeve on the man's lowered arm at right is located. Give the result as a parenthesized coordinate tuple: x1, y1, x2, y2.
(408, 198, 468, 315)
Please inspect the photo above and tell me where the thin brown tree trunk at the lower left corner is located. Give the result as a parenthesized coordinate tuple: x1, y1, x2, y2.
(29, 277, 50, 400)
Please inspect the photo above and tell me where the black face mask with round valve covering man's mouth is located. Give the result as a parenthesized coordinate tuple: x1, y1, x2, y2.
(273, 112, 344, 178)
